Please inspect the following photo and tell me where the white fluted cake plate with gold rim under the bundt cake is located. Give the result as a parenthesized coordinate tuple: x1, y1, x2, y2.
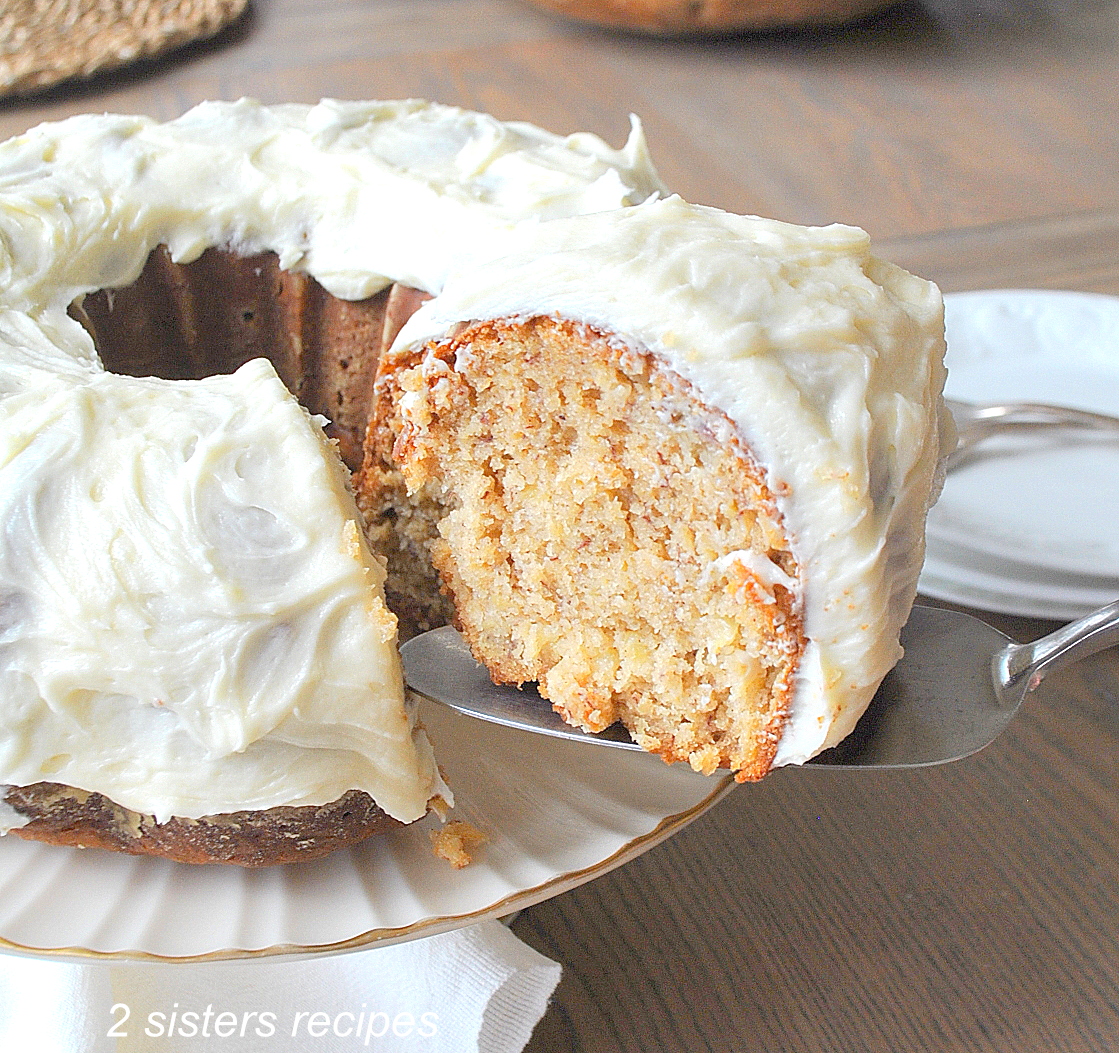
(0, 704, 734, 960)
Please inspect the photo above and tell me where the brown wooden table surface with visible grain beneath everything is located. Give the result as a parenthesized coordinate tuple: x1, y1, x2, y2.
(0, 0, 1119, 1053)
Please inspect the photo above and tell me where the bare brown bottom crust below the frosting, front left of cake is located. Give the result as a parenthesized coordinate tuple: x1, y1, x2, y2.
(4, 782, 401, 867)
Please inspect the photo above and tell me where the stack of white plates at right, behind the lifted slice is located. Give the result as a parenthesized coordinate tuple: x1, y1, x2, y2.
(921, 290, 1119, 618)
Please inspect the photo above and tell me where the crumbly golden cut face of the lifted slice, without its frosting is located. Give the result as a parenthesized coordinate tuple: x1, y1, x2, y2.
(358, 318, 805, 780)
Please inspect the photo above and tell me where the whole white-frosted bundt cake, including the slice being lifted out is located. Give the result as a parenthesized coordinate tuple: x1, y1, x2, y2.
(0, 94, 950, 865)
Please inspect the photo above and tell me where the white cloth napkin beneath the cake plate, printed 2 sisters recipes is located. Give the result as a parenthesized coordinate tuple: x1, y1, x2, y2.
(0, 921, 561, 1053)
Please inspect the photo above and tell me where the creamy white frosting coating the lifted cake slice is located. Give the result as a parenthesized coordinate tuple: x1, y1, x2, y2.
(396, 198, 955, 764)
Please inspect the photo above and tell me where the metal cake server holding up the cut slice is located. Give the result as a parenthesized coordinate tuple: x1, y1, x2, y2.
(401, 601, 1119, 769)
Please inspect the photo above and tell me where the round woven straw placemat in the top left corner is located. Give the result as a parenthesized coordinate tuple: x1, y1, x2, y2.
(0, 0, 247, 95)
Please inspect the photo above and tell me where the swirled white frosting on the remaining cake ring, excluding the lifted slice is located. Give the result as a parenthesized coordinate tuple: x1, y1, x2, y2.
(0, 101, 662, 821)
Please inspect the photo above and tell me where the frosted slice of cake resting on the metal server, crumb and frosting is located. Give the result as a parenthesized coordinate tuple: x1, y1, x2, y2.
(358, 198, 951, 779)
